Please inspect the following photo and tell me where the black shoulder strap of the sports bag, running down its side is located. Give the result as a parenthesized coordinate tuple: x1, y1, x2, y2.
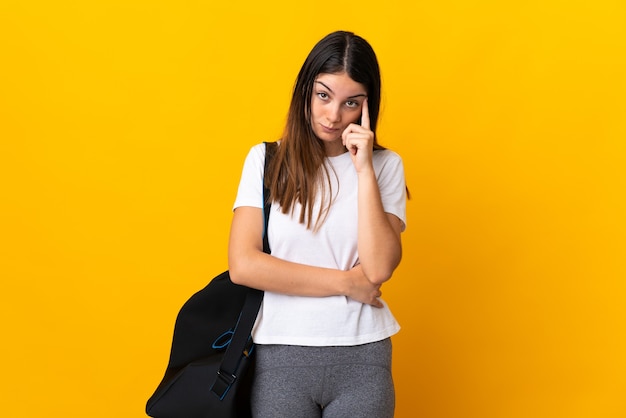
(211, 142, 276, 400)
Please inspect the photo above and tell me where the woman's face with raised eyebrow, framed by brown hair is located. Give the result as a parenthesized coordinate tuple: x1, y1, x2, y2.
(311, 72, 367, 156)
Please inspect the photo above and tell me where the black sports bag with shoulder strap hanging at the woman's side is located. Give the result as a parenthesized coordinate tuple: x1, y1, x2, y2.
(146, 143, 275, 418)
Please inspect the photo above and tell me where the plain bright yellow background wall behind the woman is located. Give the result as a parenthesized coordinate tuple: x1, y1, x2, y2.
(0, 0, 626, 418)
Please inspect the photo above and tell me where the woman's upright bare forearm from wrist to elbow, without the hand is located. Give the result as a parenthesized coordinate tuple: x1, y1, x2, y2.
(358, 170, 402, 284)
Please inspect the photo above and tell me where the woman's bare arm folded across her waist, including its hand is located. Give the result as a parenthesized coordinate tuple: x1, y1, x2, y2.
(228, 206, 382, 307)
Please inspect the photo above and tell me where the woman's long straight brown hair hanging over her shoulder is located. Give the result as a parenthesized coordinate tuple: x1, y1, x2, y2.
(265, 31, 384, 229)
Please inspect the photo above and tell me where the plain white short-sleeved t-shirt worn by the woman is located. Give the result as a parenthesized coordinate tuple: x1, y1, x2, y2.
(234, 144, 406, 346)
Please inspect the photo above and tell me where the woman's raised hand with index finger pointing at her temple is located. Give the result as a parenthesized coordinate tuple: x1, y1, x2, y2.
(341, 99, 374, 172)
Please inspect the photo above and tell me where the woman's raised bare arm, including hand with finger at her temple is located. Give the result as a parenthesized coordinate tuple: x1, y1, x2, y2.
(342, 101, 402, 284)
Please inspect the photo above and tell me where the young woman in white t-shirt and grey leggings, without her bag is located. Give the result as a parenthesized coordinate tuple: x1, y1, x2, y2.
(229, 32, 406, 418)
